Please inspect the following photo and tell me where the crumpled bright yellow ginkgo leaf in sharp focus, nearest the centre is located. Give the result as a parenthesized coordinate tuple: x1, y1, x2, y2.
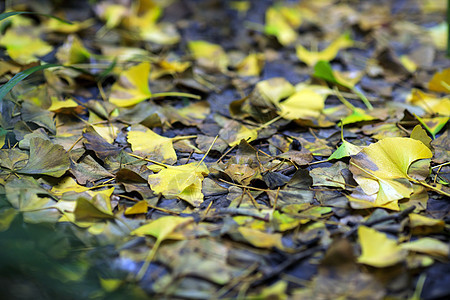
(148, 162, 209, 207)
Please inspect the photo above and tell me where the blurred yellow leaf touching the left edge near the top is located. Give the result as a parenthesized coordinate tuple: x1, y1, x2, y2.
(0, 30, 53, 65)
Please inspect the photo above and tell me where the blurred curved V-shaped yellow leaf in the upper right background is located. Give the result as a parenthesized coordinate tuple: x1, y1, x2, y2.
(296, 33, 353, 67)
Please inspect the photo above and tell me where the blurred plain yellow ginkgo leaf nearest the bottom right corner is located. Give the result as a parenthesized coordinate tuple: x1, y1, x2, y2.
(358, 226, 407, 268)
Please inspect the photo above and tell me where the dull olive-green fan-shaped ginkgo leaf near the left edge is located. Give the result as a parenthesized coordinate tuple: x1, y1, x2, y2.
(17, 138, 70, 177)
